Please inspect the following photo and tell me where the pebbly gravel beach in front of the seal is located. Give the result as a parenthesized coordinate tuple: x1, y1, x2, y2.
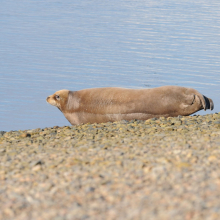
(0, 113, 220, 220)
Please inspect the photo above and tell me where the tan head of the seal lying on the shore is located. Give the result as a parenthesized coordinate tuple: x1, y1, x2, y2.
(46, 89, 69, 111)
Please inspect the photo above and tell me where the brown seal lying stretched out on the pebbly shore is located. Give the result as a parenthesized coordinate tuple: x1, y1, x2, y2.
(46, 86, 214, 125)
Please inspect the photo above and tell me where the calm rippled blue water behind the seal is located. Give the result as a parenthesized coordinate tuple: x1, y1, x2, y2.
(0, 0, 220, 131)
